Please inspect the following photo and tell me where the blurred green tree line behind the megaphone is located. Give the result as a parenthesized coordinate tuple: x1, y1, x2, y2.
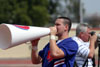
(0, 0, 99, 26)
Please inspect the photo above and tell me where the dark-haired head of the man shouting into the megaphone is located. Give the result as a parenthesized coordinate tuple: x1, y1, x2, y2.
(55, 17, 72, 34)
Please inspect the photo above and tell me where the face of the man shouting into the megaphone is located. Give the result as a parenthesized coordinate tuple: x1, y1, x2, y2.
(55, 19, 65, 36)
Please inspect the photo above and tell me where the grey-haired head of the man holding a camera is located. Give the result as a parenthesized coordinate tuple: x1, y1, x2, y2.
(76, 24, 90, 42)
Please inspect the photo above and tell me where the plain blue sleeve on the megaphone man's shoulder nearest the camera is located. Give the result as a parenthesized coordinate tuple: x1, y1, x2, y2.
(60, 41, 78, 57)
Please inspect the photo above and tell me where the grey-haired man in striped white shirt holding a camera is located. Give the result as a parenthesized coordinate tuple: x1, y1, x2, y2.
(73, 24, 97, 67)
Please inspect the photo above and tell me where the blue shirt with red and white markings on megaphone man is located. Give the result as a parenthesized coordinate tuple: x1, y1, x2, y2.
(39, 38, 78, 67)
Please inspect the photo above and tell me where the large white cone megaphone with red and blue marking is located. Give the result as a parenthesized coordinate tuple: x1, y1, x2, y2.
(0, 24, 50, 49)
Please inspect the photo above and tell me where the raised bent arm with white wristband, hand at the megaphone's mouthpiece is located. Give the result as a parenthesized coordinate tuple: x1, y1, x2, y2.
(50, 27, 65, 59)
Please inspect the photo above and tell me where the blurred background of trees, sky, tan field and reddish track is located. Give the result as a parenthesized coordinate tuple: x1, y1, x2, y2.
(0, 0, 100, 67)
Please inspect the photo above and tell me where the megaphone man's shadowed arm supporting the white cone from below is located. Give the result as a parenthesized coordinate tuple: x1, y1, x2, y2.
(31, 39, 42, 64)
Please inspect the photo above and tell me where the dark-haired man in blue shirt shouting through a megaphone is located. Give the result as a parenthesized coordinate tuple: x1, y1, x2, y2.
(32, 17, 78, 67)
